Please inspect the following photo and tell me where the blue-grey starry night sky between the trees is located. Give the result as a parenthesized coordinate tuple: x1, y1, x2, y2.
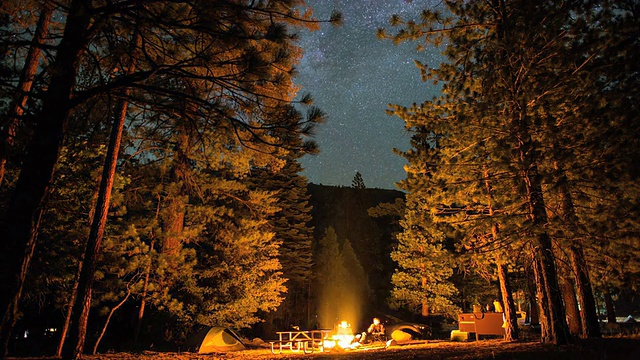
(296, 0, 441, 189)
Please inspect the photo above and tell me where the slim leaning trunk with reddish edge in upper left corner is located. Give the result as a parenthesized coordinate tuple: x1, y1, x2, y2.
(0, 1, 53, 186)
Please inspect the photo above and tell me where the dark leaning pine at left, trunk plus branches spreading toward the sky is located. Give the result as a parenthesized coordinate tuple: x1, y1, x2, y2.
(0, 0, 337, 354)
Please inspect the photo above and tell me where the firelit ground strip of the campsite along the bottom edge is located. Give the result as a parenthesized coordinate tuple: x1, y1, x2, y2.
(8, 336, 640, 360)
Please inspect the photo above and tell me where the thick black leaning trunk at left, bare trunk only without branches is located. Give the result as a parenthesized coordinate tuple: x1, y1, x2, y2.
(0, 0, 92, 355)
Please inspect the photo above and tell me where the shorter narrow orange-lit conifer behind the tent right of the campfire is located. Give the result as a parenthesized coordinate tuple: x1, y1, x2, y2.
(391, 132, 458, 318)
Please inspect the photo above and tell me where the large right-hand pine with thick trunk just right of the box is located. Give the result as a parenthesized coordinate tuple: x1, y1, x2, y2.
(381, 1, 628, 343)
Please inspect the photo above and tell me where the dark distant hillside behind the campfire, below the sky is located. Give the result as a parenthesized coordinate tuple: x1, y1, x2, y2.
(307, 184, 404, 308)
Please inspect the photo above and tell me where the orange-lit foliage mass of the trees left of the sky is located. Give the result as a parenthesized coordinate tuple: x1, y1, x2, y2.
(0, 0, 340, 352)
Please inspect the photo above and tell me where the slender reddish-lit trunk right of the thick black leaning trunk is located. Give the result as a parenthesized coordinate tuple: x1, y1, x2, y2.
(63, 31, 142, 359)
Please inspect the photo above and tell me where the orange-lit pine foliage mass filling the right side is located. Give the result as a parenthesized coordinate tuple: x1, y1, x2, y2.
(379, 1, 638, 332)
